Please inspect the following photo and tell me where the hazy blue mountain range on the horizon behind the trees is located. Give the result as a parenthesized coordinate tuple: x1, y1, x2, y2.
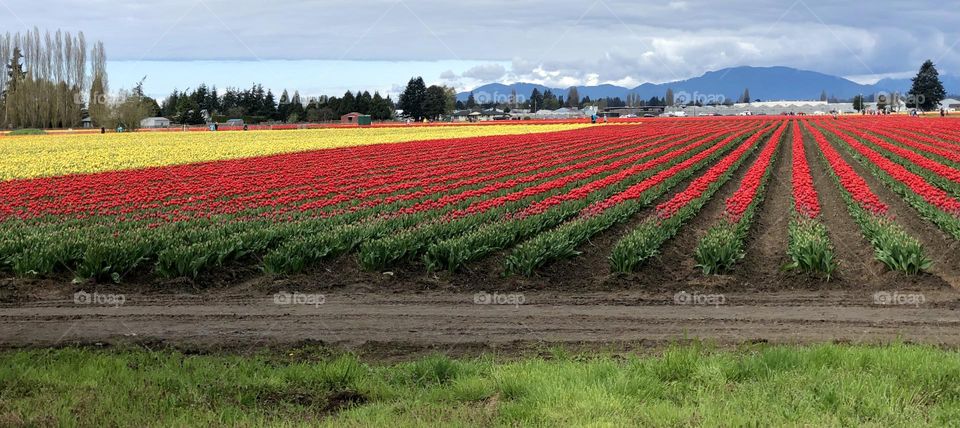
(457, 66, 960, 102)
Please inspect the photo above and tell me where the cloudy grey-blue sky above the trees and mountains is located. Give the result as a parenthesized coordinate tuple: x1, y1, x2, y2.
(0, 0, 960, 95)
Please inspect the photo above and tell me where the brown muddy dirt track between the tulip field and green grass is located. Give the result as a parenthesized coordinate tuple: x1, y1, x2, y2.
(0, 289, 960, 354)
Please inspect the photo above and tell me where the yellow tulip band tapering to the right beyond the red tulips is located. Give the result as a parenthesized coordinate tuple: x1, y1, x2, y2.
(0, 124, 585, 180)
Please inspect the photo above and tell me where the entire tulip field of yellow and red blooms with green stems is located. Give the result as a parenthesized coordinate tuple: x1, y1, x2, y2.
(0, 116, 960, 283)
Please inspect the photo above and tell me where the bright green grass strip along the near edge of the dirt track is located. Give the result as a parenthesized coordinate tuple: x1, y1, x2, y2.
(0, 344, 960, 427)
